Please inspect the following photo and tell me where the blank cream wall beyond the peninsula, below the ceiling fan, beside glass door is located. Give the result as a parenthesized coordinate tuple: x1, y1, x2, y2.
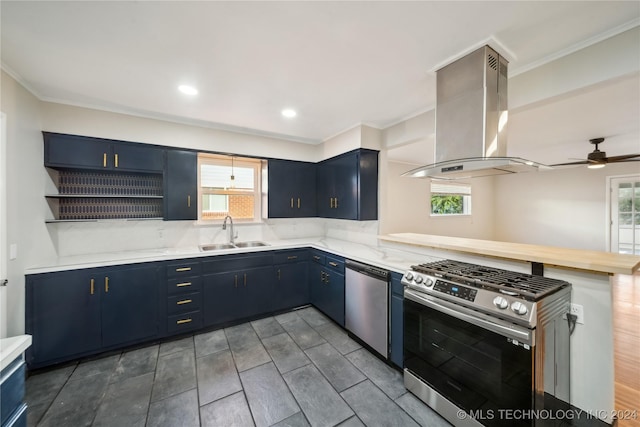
(494, 162, 640, 251)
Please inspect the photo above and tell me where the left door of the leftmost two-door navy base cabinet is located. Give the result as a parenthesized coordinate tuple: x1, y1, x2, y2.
(26, 270, 102, 365)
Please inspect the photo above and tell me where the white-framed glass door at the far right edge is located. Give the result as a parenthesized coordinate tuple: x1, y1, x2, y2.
(609, 176, 640, 255)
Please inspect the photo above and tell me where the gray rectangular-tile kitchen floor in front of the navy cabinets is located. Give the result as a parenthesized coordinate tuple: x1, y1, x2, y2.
(26, 307, 449, 427)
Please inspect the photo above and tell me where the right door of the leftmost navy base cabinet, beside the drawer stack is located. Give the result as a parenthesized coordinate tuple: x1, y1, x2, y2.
(100, 265, 162, 347)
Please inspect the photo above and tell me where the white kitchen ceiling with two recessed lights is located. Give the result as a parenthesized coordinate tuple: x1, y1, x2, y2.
(0, 0, 640, 155)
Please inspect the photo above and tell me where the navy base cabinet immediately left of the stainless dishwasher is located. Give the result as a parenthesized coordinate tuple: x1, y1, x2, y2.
(309, 251, 344, 327)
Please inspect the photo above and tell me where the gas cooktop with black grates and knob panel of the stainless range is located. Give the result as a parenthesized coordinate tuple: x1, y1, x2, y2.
(402, 260, 571, 328)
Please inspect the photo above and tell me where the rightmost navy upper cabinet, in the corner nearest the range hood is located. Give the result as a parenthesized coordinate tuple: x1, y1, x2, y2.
(316, 149, 378, 221)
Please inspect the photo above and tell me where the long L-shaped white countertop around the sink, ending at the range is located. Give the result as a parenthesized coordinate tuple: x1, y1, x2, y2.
(25, 237, 440, 275)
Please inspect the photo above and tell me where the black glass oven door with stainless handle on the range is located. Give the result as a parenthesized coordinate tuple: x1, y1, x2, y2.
(404, 289, 535, 426)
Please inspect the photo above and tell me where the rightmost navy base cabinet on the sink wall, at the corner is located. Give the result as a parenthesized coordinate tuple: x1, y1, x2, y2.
(272, 249, 309, 311)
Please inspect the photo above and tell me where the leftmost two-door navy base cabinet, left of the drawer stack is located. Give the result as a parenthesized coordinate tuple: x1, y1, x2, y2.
(26, 264, 159, 367)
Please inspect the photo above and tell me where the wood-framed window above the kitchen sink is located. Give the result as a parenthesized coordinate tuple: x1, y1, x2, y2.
(198, 154, 262, 222)
